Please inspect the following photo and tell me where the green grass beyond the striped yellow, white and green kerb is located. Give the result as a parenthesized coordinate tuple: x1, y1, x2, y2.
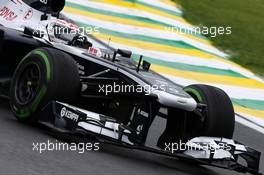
(175, 0, 264, 75)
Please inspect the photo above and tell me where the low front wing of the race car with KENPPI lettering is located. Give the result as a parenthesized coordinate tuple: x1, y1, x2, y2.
(39, 101, 261, 175)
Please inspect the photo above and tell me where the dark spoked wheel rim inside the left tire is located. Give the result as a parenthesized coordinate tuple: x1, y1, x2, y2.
(15, 63, 41, 105)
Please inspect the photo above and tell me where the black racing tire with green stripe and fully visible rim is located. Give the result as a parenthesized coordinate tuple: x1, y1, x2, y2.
(10, 48, 80, 123)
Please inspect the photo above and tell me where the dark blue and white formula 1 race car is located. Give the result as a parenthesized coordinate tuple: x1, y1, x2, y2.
(0, 0, 260, 174)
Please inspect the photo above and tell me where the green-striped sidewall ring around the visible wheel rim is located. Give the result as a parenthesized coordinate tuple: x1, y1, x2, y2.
(10, 49, 52, 120)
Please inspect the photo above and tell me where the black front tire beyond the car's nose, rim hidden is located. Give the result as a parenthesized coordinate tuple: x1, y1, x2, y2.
(184, 84, 235, 139)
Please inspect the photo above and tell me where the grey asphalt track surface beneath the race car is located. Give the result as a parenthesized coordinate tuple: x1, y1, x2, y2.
(0, 101, 264, 175)
